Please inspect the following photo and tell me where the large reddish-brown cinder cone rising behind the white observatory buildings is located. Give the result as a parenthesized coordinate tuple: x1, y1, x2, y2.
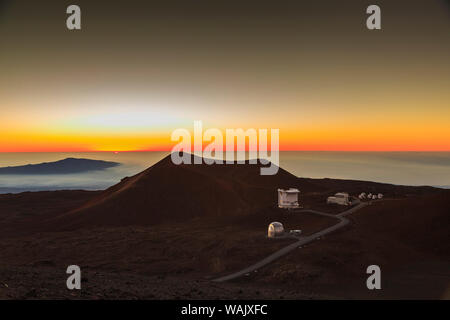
(46, 156, 321, 230)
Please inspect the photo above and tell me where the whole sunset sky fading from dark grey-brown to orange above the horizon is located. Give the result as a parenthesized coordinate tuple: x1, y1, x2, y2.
(0, 0, 450, 152)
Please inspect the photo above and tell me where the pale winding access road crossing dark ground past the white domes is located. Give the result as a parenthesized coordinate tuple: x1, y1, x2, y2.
(213, 202, 369, 282)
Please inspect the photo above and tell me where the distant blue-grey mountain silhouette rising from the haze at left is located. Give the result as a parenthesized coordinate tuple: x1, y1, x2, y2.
(0, 158, 120, 174)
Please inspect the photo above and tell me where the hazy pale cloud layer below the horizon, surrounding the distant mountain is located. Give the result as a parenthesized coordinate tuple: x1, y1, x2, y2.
(0, 151, 450, 193)
